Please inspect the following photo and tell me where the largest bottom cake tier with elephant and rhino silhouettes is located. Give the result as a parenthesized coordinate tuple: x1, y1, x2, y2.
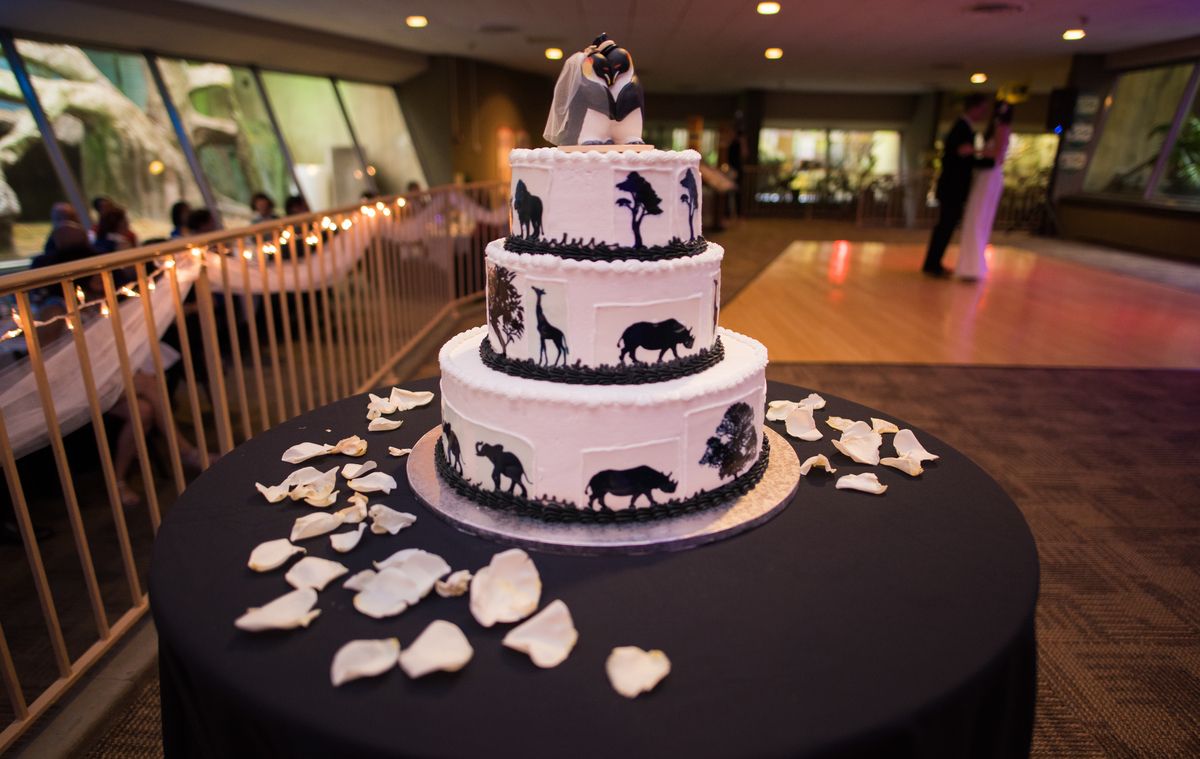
(437, 327, 767, 521)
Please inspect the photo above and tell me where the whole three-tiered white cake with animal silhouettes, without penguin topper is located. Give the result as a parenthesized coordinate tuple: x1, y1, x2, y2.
(436, 149, 767, 522)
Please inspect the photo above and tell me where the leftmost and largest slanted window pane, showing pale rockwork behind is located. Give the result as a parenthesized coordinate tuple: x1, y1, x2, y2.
(17, 40, 203, 240)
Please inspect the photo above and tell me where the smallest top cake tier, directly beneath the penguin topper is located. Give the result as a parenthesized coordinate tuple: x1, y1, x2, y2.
(509, 148, 702, 253)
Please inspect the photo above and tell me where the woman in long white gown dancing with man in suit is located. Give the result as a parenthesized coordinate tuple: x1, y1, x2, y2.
(954, 101, 1013, 282)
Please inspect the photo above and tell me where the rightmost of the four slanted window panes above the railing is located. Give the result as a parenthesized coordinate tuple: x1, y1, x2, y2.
(337, 82, 427, 195)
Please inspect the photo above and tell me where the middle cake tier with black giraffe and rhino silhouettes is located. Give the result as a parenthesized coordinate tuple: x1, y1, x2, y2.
(484, 240, 725, 383)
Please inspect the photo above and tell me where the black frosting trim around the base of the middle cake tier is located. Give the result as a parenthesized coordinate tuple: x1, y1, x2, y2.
(479, 336, 725, 384)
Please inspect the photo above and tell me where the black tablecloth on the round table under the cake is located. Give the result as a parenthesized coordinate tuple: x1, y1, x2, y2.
(150, 381, 1038, 757)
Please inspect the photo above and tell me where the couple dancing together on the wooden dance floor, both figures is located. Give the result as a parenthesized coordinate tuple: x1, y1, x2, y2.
(922, 94, 1013, 282)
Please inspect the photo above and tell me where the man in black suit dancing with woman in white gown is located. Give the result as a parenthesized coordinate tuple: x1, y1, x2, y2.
(920, 92, 995, 276)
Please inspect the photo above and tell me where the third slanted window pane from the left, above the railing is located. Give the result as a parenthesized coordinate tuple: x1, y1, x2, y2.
(263, 71, 366, 210)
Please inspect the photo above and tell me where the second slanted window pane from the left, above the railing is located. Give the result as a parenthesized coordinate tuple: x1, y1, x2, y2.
(158, 59, 295, 227)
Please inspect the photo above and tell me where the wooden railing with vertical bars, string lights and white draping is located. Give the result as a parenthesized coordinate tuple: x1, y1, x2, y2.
(0, 183, 508, 752)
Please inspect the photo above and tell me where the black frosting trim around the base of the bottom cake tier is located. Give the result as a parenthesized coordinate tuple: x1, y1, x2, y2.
(433, 435, 770, 525)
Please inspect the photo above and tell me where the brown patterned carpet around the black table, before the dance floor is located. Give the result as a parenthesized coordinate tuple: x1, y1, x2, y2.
(77, 365, 1200, 758)
